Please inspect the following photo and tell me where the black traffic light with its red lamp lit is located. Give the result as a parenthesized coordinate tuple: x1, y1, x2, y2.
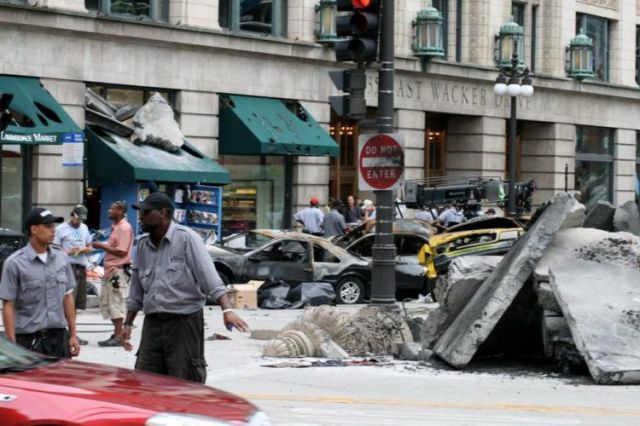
(334, 0, 381, 63)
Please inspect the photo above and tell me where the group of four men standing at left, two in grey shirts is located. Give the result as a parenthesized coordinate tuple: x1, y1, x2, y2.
(0, 192, 248, 383)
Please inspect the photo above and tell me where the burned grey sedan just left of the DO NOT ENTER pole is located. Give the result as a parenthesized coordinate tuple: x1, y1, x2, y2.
(208, 232, 371, 304)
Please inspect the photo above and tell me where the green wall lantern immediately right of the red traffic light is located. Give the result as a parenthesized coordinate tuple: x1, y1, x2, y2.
(411, 1, 444, 58)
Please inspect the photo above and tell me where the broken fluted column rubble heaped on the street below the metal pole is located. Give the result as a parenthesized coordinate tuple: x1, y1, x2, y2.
(263, 306, 413, 359)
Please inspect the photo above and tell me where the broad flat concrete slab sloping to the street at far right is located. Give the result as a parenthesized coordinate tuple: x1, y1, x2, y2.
(550, 260, 640, 385)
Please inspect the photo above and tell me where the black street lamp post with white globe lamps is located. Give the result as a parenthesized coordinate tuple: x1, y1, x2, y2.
(493, 41, 533, 216)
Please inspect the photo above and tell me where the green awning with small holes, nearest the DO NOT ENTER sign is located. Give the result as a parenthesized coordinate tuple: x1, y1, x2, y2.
(219, 95, 340, 156)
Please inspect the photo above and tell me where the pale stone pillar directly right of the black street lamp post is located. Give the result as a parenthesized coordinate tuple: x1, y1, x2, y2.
(520, 122, 576, 205)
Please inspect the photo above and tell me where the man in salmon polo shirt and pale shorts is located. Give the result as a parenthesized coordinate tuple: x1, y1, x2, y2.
(93, 201, 133, 347)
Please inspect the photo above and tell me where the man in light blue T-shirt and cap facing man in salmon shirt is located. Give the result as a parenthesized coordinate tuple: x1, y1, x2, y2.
(53, 204, 93, 345)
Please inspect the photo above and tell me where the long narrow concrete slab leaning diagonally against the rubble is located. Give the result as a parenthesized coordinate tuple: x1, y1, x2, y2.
(434, 193, 584, 368)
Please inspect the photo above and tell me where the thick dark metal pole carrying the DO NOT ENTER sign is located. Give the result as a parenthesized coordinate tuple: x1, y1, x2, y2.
(371, 0, 397, 309)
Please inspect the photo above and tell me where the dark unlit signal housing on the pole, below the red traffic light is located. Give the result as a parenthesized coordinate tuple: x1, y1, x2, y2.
(329, 68, 367, 120)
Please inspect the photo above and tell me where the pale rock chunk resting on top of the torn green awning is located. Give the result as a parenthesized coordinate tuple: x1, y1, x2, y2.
(133, 92, 184, 152)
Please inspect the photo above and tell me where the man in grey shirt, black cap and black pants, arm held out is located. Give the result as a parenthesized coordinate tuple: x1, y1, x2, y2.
(123, 192, 248, 383)
